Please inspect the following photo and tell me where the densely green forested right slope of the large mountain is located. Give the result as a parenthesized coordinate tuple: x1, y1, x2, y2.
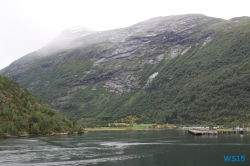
(78, 18, 250, 126)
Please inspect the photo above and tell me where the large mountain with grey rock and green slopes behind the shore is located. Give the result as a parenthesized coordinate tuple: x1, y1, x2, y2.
(1, 14, 250, 125)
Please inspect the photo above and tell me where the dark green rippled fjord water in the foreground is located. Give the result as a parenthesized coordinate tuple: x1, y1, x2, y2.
(0, 130, 250, 166)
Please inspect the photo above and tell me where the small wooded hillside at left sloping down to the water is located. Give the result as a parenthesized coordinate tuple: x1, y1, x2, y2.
(0, 76, 78, 136)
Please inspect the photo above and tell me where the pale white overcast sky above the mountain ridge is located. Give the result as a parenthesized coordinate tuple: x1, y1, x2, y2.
(0, 0, 250, 69)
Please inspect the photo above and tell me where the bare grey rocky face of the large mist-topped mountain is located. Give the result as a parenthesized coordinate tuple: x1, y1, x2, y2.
(1, 15, 250, 126)
